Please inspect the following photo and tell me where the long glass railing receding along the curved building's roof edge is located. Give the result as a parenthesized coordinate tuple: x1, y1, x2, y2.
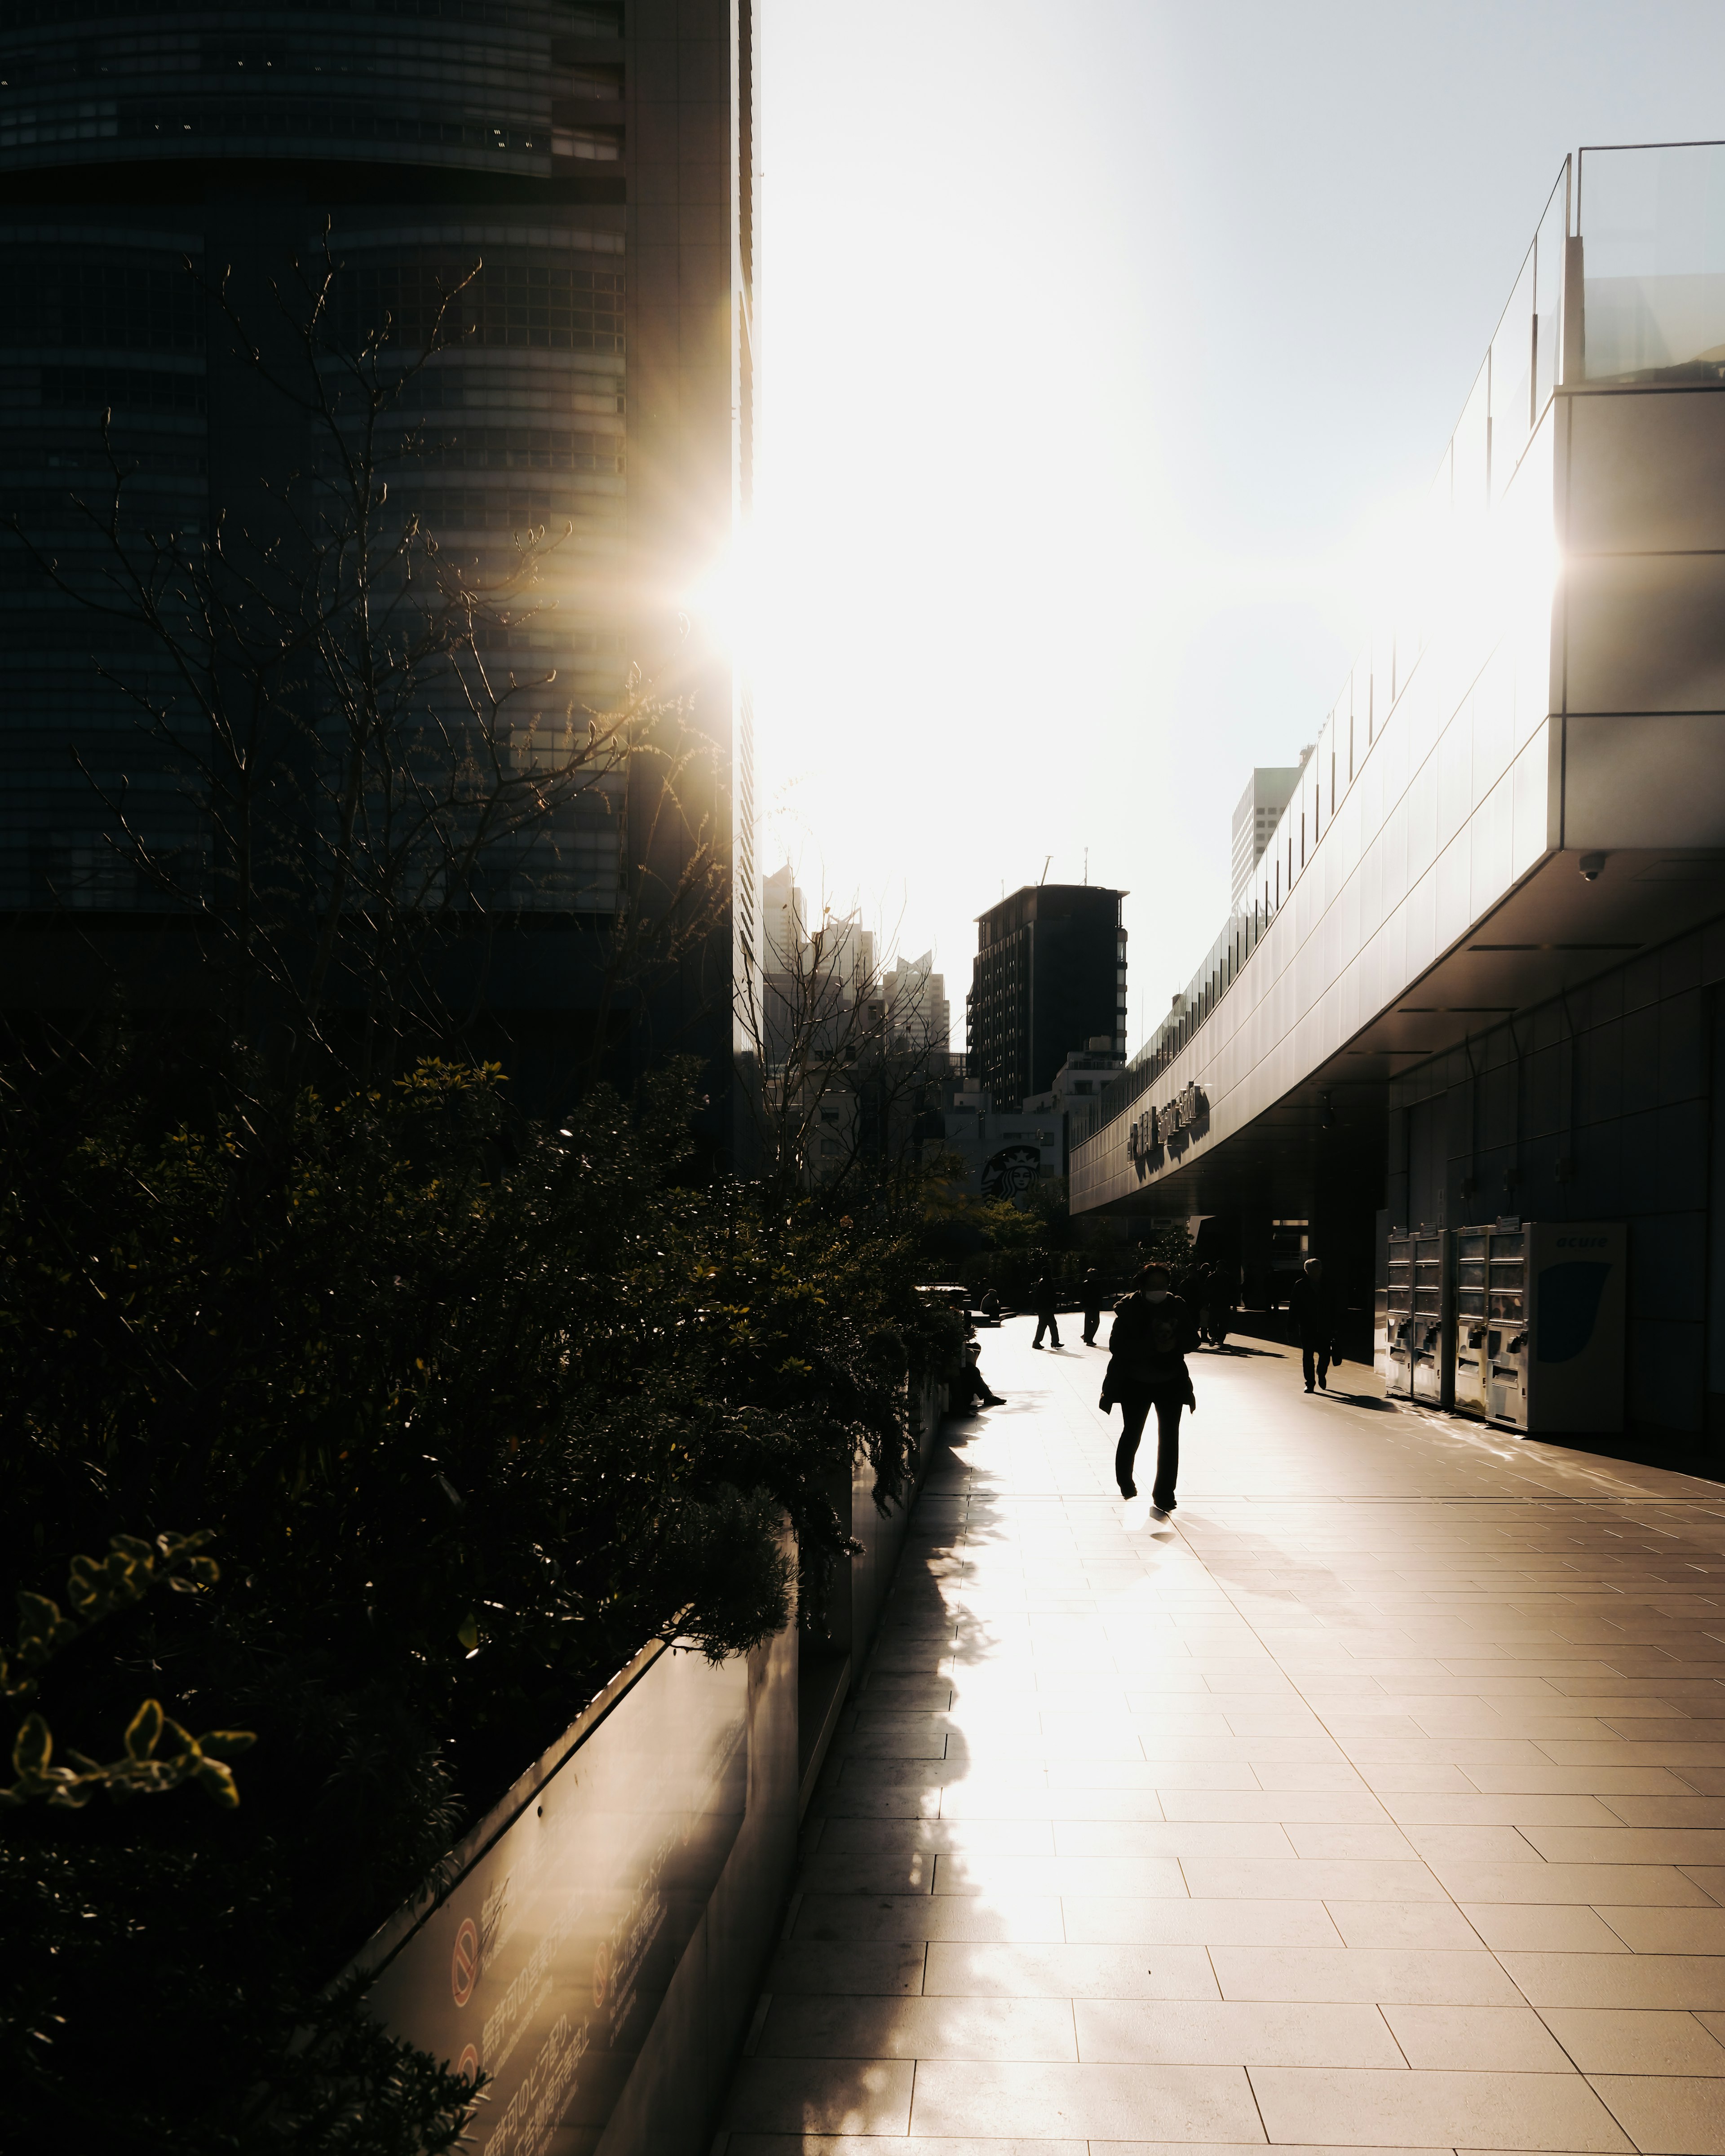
(1072, 151, 1570, 1145)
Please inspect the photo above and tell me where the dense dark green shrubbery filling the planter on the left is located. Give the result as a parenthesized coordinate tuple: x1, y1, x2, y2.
(0, 1043, 953, 2156)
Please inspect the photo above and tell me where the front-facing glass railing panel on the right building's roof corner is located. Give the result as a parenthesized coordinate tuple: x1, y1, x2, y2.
(1576, 142, 1725, 382)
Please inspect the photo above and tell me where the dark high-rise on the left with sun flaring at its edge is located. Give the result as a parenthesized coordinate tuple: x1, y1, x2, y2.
(0, 0, 757, 1147)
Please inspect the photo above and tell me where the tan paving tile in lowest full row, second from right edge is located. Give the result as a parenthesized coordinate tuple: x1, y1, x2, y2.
(1251, 2065, 1632, 2150)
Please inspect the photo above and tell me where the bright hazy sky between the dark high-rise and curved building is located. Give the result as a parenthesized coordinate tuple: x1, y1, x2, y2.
(744, 0, 1725, 1048)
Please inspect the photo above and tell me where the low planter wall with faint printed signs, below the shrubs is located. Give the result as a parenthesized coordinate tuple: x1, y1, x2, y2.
(356, 1386, 944, 2156)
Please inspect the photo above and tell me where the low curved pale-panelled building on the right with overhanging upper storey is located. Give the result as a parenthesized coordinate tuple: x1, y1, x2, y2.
(1072, 145, 1725, 1449)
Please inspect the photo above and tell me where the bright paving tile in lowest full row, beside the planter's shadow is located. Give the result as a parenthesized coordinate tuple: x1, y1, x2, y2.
(912, 2059, 1259, 2147)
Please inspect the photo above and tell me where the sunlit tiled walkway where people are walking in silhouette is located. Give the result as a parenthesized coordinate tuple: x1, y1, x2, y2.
(720, 1321, 1725, 2156)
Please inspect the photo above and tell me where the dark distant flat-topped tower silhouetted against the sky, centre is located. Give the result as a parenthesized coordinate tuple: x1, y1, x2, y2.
(966, 884, 1126, 1102)
